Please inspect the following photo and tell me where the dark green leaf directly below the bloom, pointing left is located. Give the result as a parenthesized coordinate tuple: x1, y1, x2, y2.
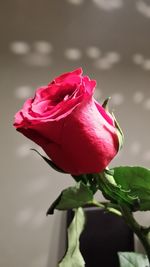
(47, 182, 93, 215)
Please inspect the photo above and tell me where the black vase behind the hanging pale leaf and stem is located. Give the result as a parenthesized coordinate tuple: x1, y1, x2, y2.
(67, 207, 134, 267)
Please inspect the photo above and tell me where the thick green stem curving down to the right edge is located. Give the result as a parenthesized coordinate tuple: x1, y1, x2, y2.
(120, 204, 150, 263)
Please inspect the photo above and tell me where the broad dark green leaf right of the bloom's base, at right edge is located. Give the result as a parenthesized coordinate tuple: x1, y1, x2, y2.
(113, 166, 150, 211)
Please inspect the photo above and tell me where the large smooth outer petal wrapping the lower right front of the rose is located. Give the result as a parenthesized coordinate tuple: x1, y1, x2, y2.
(41, 101, 118, 175)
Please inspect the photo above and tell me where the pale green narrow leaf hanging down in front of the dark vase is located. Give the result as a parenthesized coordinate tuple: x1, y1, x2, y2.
(59, 208, 85, 267)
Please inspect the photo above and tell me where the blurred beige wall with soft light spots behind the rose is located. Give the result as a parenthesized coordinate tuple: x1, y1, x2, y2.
(0, 0, 150, 267)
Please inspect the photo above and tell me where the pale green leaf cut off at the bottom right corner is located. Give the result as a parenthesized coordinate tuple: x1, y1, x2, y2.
(118, 252, 149, 267)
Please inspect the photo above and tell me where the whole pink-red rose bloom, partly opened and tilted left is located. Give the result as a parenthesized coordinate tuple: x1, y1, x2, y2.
(14, 68, 119, 175)
